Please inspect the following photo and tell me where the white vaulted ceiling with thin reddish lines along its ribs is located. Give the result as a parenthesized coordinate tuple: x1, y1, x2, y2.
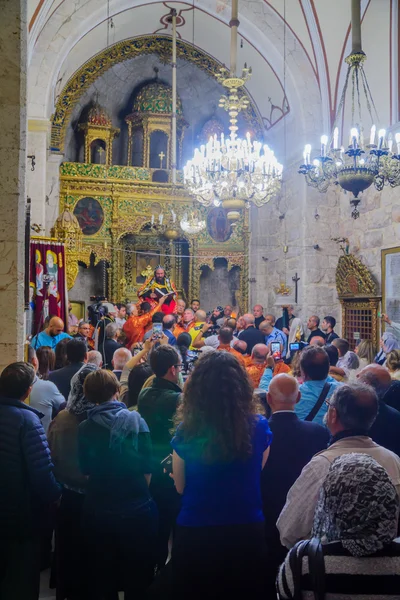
(28, 0, 397, 158)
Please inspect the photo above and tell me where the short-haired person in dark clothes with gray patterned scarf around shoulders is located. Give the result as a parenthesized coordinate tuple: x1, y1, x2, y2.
(79, 369, 158, 600)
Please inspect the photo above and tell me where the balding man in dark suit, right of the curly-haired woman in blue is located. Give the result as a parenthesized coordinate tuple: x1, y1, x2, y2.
(261, 373, 330, 598)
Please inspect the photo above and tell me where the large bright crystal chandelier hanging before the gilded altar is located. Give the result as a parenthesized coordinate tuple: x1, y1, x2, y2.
(183, 0, 282, 224)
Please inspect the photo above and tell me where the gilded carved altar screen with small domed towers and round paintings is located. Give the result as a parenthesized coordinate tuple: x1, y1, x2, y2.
(54, 72, 253, 312)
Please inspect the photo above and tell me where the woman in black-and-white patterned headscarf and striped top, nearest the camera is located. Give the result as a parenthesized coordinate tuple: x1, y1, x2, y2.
(277, 453, 400, 600)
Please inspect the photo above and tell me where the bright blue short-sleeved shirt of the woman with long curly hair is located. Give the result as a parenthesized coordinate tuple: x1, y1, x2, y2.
(171, 415, 272, 527)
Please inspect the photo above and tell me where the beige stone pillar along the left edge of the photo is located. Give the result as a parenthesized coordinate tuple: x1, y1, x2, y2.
(0, 0, 27, 371)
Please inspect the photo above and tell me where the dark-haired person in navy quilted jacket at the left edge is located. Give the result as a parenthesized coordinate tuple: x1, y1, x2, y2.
(0, 362, 61, 600)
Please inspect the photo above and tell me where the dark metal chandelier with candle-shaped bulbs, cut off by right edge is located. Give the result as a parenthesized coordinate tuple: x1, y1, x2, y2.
(299, 0, 400, 219)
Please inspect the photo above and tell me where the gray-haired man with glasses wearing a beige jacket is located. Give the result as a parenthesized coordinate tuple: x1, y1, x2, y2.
(271, 382, 400, 548)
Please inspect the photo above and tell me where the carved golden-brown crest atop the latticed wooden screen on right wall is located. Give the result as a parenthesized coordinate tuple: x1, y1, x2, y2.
(336, 254, 377, 298)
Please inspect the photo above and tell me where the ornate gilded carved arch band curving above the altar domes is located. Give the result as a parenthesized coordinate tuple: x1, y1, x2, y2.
(51, 35, 263, 152)
